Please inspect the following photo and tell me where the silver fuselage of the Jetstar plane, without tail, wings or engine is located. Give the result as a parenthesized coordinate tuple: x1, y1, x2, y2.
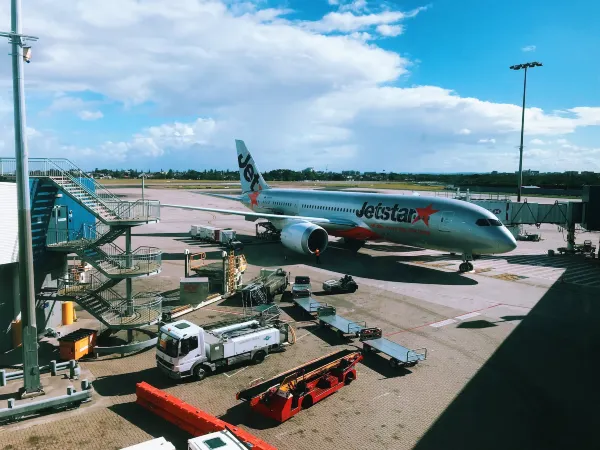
(242, 189, 516, 255)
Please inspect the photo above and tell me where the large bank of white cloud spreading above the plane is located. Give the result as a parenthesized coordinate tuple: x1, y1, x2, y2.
(0, 0, 600, 171)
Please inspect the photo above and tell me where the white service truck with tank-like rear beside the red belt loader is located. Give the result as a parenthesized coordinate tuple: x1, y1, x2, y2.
(156, 320, 289, 380)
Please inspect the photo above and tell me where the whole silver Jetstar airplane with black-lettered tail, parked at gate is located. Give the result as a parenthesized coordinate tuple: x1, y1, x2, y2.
(162, 139, 517, 272)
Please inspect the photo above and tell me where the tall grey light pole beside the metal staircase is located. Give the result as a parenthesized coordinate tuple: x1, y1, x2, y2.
(0, 0, 44, 398)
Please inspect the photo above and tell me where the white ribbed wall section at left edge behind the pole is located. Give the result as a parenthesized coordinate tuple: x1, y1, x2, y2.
(0, 183, 19, 264)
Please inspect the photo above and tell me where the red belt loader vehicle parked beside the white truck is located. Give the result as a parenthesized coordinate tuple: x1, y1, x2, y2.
(236, 350, 363, 422)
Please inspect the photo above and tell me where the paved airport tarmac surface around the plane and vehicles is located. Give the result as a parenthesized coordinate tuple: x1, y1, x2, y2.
(0, 188, 600, 450)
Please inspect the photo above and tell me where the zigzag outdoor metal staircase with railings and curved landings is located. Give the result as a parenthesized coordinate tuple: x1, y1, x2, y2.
(0, 158, 162, 329)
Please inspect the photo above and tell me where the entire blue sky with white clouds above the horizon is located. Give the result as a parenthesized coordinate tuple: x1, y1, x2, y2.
(0, 0, 600, 172)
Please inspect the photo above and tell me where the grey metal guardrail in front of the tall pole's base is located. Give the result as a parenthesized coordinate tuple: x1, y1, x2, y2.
(0, 380, 92, 423)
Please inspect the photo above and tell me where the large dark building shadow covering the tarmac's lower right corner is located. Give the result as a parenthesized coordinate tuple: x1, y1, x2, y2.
(414, 284, 600, 450)
